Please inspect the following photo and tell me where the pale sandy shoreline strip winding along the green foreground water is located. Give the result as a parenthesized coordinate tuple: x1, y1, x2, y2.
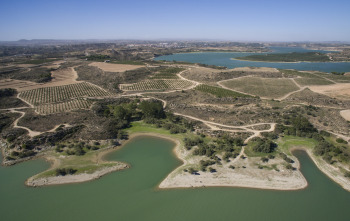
(2, 132, 350, 191)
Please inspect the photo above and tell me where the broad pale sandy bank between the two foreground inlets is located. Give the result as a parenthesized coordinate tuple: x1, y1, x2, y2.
(159, 145, 307, 190)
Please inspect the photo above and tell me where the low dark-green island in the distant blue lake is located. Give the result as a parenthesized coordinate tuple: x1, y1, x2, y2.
(235, 52, 330, 62)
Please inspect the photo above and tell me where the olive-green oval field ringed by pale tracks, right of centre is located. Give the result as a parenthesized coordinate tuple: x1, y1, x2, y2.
(221, 77, 299, 98)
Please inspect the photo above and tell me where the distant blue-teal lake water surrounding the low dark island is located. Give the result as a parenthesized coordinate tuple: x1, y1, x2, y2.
(155, 47, 350, 72)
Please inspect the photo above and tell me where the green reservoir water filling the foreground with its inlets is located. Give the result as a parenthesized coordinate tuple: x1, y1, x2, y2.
(0, 136, 350, 221)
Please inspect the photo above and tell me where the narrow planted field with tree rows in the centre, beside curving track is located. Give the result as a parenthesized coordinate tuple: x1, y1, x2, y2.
(120, 79, 193, 91)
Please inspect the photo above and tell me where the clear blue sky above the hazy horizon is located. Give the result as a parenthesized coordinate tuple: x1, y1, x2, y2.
(0, 0, 350, 42)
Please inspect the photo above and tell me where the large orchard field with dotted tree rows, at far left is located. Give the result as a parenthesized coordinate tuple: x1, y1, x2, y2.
(19, 82, 111, 106)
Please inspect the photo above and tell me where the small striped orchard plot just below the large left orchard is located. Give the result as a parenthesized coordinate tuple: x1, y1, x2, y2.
(35, 99, 93, 114)
